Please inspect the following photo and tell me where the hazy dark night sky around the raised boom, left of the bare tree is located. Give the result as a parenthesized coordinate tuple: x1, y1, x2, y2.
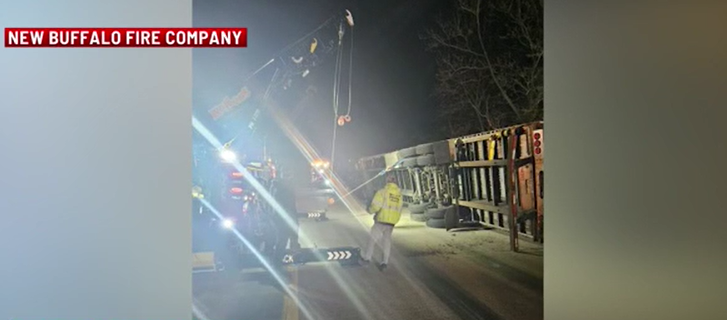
(193, 0, 450, 162)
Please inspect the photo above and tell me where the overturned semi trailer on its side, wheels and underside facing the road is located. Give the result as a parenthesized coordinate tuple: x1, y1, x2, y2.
(357, 122, 544, 250)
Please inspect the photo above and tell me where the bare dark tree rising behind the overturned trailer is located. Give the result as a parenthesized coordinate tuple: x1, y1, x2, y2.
(425, 0, 543, 135)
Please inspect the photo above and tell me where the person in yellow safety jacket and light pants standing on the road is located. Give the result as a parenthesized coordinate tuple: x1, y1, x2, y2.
(361, 173, 403, 271)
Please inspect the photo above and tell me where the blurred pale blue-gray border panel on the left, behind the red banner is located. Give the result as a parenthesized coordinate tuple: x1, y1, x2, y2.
(0, 0, 192, 320)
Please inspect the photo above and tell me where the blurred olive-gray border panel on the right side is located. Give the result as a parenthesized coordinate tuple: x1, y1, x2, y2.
(545, 1, 727, 320)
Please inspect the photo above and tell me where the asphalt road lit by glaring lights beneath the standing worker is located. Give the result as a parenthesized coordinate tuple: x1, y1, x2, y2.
(193, 202, 543, 320)
